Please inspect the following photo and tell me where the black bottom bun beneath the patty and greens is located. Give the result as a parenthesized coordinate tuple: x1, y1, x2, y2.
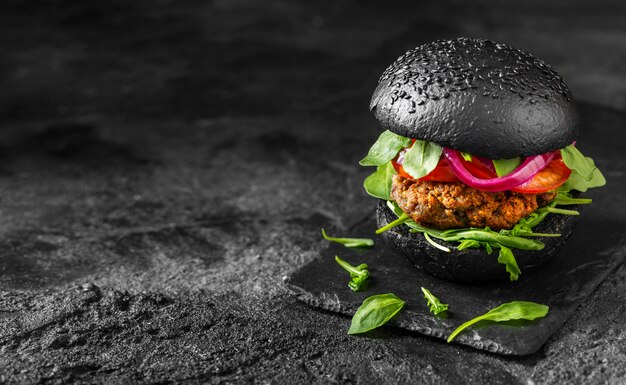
(376, 200, 579, 283)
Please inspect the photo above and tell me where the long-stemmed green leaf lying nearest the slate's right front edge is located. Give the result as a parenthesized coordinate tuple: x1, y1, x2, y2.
(448, 301, 549, 342)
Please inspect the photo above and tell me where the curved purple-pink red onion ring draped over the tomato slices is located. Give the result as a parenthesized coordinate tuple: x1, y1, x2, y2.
(443, 148, 556, 192)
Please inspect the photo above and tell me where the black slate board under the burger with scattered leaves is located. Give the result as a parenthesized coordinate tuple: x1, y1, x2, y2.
(286, 104, 626, 355)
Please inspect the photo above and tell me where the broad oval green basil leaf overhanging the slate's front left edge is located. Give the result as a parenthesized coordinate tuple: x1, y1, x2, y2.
(348, 293, 405, 334)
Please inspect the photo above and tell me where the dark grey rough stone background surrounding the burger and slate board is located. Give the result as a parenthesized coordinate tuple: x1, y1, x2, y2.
(0, 0, 626, 384)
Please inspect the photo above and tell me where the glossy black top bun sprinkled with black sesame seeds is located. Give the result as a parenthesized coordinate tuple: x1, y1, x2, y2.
(370, 38, 579, 159)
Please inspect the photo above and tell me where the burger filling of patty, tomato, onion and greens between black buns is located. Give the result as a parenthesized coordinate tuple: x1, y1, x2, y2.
(359, 131, 605, 281)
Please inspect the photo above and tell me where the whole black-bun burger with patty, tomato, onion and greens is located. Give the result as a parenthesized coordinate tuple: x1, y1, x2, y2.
(360, 38, 605, 282)
